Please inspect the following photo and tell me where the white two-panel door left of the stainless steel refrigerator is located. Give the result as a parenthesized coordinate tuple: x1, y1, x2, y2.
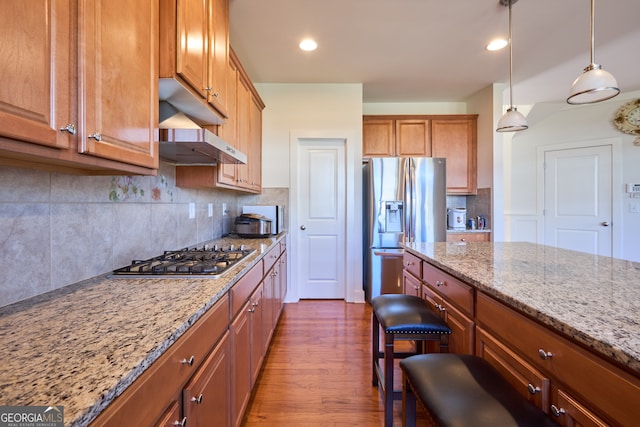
(294, 139, 347, 299)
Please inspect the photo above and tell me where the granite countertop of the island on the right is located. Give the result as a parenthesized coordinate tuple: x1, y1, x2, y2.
(405, 242, 640, 374)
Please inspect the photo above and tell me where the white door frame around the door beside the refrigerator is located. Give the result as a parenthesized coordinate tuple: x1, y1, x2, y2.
(285, 130, 365, 303)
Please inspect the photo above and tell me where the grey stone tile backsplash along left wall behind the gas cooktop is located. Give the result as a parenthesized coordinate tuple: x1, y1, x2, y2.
(0, 163, 288, 306)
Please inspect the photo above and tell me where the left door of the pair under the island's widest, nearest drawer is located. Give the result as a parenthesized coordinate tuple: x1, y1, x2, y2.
(476, 327, 551, 412)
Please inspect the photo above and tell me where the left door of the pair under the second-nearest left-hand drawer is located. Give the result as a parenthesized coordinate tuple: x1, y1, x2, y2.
(230, 302, 251, 426)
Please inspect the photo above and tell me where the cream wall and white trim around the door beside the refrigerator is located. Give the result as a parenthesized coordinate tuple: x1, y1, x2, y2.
(255, 83, 364, 302)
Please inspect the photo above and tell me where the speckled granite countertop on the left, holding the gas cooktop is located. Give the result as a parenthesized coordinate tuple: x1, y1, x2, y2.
(0, 234, 285, 426)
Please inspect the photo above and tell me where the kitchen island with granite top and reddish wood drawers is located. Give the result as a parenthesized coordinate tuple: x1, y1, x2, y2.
(405, 242, 640, 425)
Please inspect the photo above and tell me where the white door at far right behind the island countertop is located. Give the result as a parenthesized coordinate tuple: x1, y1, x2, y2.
(544, 145, 613, 256)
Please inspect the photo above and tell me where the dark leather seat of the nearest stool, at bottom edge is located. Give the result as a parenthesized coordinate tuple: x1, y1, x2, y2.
(400, 354, 558, 427)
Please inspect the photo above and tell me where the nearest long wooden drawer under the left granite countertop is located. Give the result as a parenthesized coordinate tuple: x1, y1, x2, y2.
(91, 294, 229, 427)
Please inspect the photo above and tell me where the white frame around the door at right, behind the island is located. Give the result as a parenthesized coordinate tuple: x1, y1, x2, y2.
(536, 138, 623, 258)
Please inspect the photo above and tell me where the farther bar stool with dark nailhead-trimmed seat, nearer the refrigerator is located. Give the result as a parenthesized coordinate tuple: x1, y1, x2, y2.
(371, 294, 451, 427)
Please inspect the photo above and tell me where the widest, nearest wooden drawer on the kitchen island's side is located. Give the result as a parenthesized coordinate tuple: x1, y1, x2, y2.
(476, 293, 640, 425)
